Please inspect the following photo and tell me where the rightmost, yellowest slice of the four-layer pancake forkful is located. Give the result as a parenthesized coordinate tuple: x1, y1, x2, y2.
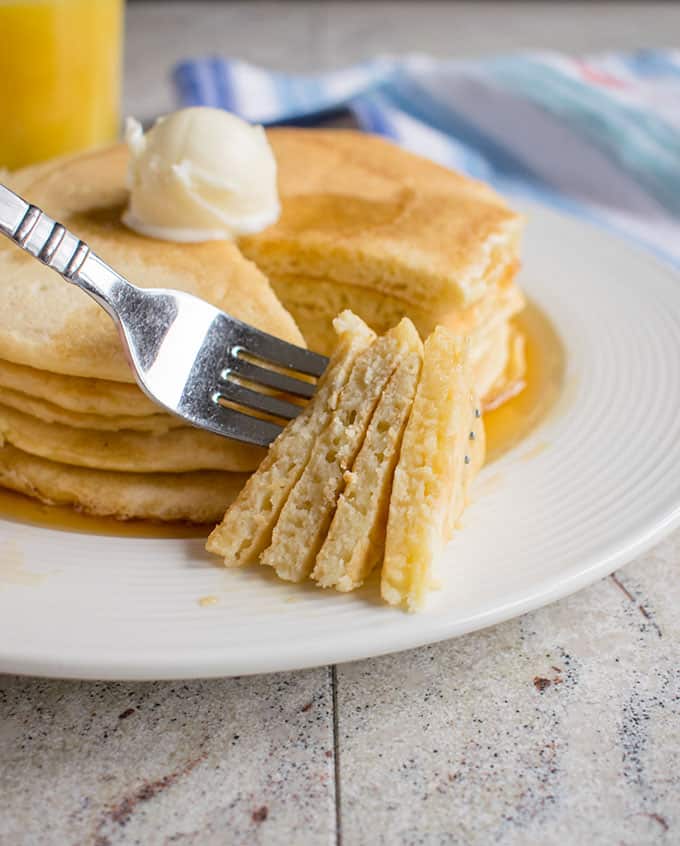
(381, 327, 484, 611)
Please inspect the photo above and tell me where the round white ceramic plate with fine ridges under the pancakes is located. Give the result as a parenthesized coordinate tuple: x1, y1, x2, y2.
(0, 208, 680, 679)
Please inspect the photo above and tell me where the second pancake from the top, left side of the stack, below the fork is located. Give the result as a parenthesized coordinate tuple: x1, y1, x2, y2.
(0, 359, 160, 417)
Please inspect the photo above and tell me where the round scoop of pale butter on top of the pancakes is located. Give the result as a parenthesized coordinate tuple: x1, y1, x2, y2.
(123, 107, 281, 242)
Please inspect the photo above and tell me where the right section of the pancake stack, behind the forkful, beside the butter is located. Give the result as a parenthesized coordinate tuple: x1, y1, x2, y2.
(239, 129, 525, 408)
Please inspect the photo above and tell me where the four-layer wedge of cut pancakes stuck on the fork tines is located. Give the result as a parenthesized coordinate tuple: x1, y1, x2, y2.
(206, 311, 485, 611)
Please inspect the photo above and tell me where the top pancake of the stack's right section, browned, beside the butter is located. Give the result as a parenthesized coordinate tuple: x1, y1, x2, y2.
(239, 128, 522, 311)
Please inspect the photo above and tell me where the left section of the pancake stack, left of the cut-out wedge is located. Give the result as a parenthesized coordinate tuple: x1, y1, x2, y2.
(0, 147, 304, 523)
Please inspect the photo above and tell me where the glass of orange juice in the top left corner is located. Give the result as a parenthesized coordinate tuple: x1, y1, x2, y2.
(0, 0, 123, 170)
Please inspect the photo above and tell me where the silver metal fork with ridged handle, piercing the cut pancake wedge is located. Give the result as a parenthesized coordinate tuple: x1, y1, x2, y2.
(0, 184, 328, 446)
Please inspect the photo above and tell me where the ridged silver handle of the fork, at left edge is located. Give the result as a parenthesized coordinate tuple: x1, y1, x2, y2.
(0, 184, 134, 321)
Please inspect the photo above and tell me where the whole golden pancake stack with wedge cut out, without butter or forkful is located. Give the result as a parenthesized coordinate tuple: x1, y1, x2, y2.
(0, 129, 523, 522)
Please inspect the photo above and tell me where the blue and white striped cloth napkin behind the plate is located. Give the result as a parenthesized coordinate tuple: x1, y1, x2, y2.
(173, 51, 680, 266)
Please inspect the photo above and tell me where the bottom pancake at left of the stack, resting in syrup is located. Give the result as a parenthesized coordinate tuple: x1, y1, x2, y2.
(0, 444, 248, 523)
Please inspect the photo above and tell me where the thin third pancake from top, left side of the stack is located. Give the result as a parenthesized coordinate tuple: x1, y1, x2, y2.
(0, 387, 181, 435)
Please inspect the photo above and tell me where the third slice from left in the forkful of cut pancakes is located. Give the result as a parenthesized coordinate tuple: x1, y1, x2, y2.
(312, 343, 422, 591)
